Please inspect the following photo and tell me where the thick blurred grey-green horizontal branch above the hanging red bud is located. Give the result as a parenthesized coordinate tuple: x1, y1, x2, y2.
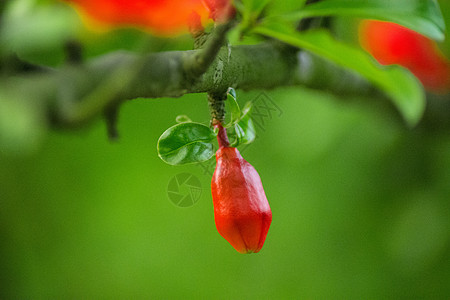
(0, 43, 376, 126)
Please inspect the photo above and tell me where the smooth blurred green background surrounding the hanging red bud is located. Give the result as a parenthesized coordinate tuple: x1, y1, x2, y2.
(0, 1, 450, 299)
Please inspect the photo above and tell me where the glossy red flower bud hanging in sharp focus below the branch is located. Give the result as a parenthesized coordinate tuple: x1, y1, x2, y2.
(211, 126, 272, 253)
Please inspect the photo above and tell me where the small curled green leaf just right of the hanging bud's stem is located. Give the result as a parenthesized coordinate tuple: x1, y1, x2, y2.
(229, 103, 256, 147)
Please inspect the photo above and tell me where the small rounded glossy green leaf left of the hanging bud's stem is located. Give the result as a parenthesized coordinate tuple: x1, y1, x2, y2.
(158, 123, 215, 165)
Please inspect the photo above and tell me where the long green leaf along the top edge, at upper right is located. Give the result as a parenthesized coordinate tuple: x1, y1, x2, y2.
(288, 0, 445, 41)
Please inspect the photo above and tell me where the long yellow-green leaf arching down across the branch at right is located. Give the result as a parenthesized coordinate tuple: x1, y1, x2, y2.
(254, 23, 425, 126)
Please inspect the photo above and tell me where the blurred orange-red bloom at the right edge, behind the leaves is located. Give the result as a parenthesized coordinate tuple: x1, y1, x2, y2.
(359, 20, 450, 93)
